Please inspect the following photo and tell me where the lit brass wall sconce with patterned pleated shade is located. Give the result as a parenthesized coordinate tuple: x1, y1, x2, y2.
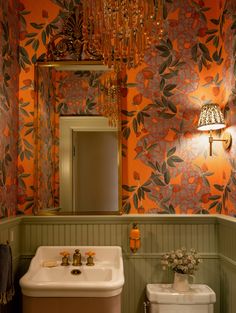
(198, 103, 232, 156)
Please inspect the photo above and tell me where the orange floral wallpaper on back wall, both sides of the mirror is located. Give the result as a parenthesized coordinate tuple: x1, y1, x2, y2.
(13, 0, 236, 215)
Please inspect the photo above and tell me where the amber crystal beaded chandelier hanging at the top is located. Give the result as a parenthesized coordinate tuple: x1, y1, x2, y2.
(83, 0, 163, 70)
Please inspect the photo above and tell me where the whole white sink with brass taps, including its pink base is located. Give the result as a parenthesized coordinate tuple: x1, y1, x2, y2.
(20, 246, 124, 313)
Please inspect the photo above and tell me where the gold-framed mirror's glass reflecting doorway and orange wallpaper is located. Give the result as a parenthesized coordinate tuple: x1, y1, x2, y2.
(34, 61, 121, 214)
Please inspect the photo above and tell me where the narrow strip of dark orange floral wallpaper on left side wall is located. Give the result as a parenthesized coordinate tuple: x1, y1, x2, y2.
(0, 0, 19, 218)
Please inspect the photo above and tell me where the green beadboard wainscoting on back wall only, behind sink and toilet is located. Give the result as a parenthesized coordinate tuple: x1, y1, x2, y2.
(21, 215, 219, 313)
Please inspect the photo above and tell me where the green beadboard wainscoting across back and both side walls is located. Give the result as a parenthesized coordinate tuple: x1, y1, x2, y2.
(0, 214, 236, 313)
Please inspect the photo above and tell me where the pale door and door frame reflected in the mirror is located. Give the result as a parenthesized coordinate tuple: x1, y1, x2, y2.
(59, 116, 119, 213)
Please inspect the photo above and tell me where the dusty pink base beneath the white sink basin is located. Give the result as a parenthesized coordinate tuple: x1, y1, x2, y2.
(23, 295, 121, 313)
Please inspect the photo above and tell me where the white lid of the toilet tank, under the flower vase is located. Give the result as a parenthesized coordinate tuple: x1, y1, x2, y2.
(146, 284, 216, 304)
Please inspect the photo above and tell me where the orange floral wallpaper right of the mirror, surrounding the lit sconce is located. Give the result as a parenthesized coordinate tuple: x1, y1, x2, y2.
(122, 1, 236, 215)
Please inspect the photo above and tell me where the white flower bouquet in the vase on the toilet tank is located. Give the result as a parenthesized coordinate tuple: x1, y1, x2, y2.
(161, 248, 202, 275)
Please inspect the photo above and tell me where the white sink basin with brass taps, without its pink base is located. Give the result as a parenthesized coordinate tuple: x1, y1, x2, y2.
(20, 246, 124, 297)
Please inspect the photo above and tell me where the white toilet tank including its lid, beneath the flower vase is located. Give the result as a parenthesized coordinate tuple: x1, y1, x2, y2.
(146, 284, 216, 313)
